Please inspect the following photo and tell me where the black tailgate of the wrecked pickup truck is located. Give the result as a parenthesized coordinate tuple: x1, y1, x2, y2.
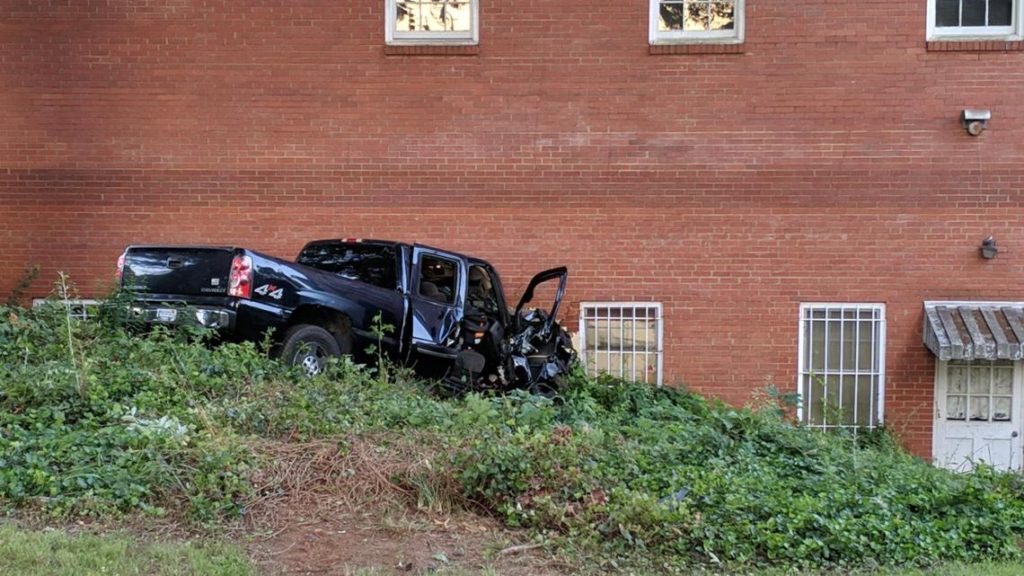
(122, 246, 236, 296)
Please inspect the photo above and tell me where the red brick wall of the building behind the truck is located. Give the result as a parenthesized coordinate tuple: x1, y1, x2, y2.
(0, 0, 1024, 455)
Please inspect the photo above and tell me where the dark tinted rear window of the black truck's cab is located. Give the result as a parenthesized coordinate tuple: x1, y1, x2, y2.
(296, 242, 398, 290)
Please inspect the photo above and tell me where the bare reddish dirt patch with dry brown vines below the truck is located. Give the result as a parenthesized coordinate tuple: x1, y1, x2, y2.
(240, 436, 571, 576)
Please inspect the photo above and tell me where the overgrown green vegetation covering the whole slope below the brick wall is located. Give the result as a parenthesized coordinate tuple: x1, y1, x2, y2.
(0, 286, 1024, 568)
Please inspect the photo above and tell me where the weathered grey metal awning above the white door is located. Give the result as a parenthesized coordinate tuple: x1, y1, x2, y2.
(925, 302, 1024, 360)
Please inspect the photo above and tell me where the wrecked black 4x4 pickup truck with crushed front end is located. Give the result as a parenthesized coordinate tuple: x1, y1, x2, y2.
(118, 239, 575, 392)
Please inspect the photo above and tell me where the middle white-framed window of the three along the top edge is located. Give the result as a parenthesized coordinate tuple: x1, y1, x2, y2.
(650, 0, 744, 44)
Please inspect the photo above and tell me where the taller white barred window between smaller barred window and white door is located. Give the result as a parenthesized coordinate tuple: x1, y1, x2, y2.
(797, 303, 886, 428)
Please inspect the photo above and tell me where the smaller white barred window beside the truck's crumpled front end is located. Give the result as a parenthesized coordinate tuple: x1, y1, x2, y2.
(580, 302, 663, 384)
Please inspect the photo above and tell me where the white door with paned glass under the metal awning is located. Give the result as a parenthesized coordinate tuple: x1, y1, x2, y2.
(933, 361, 1024, 470)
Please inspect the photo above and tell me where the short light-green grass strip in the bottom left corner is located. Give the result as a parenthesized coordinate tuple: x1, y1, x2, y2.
(0, 525, 256, 576)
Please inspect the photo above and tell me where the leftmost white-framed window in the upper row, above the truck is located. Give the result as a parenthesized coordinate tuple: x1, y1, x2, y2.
(385, 0, 480, 44)
